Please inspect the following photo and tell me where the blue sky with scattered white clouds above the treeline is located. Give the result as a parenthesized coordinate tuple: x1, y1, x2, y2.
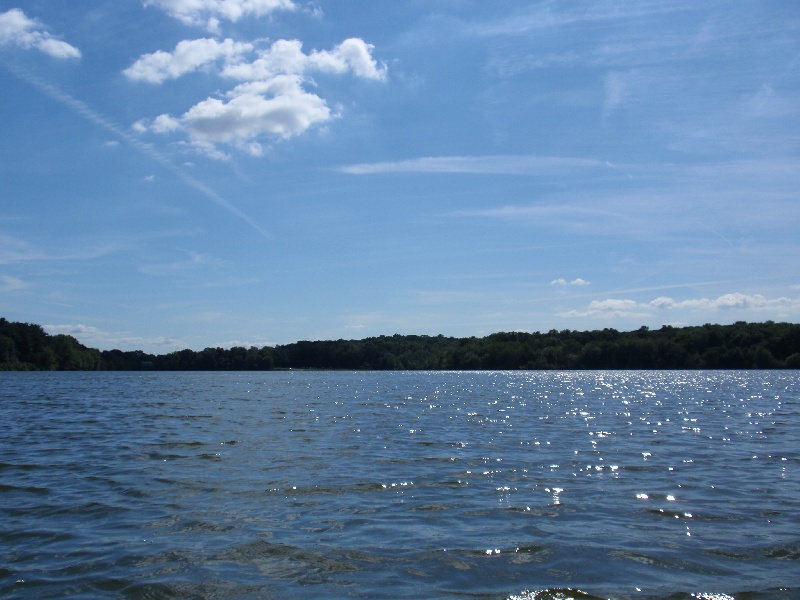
(0, 0, 800, 353)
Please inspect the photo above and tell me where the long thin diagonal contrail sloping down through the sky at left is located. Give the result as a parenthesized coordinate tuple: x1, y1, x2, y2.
(3, 65, 272, 240)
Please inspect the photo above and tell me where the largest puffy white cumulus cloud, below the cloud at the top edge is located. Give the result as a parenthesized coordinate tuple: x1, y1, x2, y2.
(131, 38, 386, 159)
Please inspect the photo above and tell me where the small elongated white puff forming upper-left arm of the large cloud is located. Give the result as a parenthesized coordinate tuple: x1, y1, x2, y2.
(123, 38, 253, 83)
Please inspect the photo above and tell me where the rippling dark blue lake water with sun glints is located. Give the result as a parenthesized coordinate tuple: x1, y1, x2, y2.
(0, 371, 800, 600)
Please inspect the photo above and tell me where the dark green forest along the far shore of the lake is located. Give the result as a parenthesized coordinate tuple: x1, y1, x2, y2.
(0, 318, 800, 371)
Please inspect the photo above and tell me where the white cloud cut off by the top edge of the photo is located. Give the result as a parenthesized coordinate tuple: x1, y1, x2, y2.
(144, 0, 297, 31)
